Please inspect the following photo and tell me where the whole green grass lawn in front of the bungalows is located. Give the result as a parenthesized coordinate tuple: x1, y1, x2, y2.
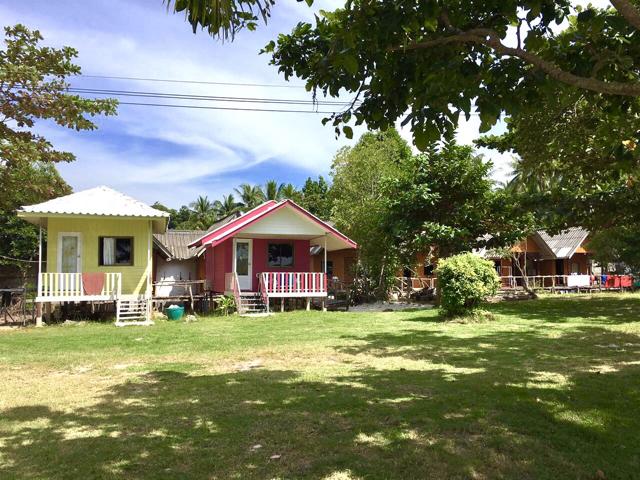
(0, 295, 640, 479)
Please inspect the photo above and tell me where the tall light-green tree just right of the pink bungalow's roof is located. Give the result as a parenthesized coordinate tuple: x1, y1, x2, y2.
(330, 129, 411, 296)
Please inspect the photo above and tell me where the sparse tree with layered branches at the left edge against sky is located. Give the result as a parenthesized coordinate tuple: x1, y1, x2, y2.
(0, 25, 117, 173)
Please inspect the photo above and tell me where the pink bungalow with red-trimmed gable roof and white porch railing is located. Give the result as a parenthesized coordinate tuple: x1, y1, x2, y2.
(189, 200, 357, 313)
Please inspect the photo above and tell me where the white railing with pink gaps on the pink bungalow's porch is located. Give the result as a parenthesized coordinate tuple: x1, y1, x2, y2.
(260, 272, 327, 298)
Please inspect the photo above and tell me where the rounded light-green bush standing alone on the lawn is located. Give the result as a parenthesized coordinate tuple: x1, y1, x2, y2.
(436, 253, 500, 317)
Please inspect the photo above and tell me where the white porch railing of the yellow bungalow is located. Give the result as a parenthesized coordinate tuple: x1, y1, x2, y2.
(38, 272, 122, 300)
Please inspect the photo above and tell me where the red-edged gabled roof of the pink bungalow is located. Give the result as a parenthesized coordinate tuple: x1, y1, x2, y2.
(189, 200, 358, 248)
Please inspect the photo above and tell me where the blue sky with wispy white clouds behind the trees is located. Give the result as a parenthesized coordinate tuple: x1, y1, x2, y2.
(0, 0, 608, 208)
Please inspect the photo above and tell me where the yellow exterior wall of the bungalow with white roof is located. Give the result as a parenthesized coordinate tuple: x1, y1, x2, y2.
(46, 217, 153, 295)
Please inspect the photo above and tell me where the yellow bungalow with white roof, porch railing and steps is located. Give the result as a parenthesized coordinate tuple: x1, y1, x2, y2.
(18, 186, 169, 325)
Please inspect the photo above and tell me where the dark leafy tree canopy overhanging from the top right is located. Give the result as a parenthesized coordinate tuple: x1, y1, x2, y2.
(264, 0, 640, 150)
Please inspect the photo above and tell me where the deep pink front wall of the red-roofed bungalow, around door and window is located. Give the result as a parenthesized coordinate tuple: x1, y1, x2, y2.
(205, 238, 311, 292)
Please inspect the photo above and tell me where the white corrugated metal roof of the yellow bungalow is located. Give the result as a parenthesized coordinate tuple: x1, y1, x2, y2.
(19, 186, 169, 218)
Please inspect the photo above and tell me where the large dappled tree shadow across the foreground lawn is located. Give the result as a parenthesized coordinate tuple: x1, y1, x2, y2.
(0, 298, 640, 479)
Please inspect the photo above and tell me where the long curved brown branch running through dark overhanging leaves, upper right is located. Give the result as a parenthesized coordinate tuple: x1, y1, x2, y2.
(389, 28, 640, 97)
